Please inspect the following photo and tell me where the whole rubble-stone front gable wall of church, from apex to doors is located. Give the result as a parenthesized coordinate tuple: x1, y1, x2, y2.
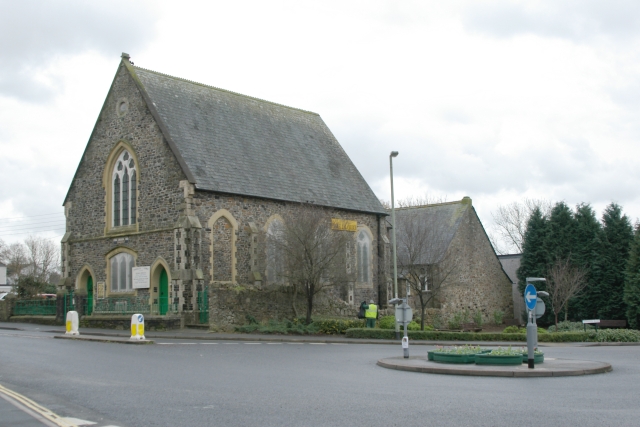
(63, 66, 186, 296)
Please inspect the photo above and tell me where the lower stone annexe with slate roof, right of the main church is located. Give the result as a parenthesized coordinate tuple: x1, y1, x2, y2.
(396, 197, 514, 326)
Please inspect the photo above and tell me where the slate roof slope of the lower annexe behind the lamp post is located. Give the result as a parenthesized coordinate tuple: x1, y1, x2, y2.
(396, 197, 472, 265)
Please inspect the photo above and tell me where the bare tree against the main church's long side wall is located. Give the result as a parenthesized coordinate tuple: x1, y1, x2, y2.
(275, 205, 351, 324)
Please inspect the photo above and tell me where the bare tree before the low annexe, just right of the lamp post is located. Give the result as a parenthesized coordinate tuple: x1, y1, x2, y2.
(396, 208, 457, 330)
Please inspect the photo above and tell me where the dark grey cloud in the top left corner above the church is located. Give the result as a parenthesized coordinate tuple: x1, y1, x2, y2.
(0, 0, 157, 102)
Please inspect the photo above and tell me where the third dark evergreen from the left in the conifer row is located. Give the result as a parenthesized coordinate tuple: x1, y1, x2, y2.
(569, 203, 604, 319)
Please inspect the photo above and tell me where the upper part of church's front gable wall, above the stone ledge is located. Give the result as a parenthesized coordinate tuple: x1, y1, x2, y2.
(67, 66, 185, 240)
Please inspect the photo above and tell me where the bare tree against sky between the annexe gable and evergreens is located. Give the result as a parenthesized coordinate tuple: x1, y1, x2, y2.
(489, 198, 551, 254)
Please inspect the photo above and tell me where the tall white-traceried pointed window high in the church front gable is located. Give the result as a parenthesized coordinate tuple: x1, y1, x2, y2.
(112, 150, 138, 227)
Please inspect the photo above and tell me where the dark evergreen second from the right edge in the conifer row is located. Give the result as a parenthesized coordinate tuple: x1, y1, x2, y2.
(598, 203, 633, 319)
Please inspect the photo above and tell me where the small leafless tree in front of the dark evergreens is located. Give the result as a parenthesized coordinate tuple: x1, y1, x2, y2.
(547, 258, 587, 330)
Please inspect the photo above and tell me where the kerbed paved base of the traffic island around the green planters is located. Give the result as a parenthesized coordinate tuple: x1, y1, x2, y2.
(378, 356, 613, 378)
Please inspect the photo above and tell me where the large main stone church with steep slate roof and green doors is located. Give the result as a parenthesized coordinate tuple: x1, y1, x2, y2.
(61, 54, 389, 329)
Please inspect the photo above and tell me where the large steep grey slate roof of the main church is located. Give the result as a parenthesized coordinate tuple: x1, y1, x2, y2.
(123, 58, 386, 215)
